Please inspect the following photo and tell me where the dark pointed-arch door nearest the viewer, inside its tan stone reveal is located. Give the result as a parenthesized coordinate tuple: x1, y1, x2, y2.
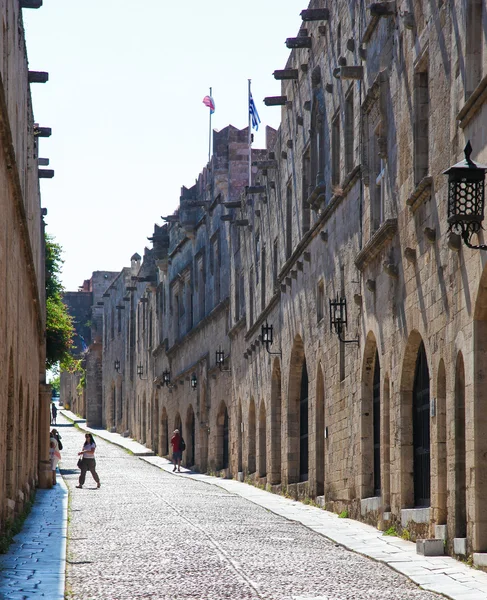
(413, 342, 431, 507)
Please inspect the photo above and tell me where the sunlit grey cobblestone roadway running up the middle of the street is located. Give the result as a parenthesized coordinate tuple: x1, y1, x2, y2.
(61, 427, 439, 600)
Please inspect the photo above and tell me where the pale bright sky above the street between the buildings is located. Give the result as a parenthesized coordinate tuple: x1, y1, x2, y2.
(23, 0, 308, 291)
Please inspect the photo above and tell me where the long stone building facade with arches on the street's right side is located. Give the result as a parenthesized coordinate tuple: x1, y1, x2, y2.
(86, 0, 487, 564)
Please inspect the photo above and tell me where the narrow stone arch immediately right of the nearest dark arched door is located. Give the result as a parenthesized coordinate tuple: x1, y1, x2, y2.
(432, 359, 448, 525)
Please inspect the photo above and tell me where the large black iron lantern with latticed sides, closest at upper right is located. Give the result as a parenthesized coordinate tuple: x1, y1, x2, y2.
(443, 141, 487, 250)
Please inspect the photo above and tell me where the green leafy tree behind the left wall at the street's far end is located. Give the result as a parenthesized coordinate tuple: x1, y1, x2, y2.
(45, 234, 74, 369)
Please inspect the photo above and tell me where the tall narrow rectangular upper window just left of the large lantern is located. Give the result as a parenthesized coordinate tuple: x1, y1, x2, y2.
(413, 67, 430, 185)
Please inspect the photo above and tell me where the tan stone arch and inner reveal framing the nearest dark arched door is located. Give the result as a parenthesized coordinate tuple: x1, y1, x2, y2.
(397, 330, 429, 508)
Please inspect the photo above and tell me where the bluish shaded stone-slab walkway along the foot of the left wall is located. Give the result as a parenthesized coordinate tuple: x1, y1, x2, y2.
(0, 475, 68, 600)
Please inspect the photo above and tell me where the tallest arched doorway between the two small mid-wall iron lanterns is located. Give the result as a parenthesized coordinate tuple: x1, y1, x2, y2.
(286, 335, 306, 483)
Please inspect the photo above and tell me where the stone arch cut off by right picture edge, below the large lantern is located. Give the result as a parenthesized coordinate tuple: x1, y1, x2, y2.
(469, 266, 487, 552)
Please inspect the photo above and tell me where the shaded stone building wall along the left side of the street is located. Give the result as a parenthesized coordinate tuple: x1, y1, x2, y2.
(0, 0, 52, 535)
